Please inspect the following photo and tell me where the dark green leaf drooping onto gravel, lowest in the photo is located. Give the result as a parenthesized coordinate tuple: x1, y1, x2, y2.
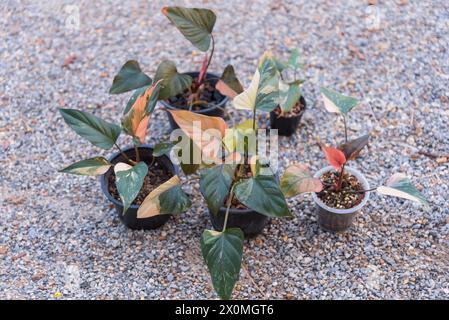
(201, 228, 243, 299)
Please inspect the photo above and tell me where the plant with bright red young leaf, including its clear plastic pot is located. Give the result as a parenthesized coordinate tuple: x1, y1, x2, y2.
(281, 87, 428, 232)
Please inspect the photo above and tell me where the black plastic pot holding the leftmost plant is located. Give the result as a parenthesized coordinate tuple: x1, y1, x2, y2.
(100, 145, 177, 230)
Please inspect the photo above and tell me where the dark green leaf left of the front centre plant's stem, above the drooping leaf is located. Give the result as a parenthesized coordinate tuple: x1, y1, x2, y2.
(200, 164, 236, 214)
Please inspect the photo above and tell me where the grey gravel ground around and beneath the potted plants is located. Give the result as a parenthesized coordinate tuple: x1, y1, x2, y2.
(0, 0, 449, 299)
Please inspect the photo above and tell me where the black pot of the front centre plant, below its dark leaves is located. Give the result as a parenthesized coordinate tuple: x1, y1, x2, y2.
(209, 207, 270, 237)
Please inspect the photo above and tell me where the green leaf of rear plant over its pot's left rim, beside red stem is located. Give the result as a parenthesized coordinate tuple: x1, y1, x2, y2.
(154, 60, 192, 100)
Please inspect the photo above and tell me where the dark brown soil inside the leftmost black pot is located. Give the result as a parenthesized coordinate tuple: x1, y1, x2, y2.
(108, 159, 173, 206)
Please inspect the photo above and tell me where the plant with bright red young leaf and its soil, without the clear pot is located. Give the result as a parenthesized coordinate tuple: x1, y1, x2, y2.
(281, 87, 428, 220)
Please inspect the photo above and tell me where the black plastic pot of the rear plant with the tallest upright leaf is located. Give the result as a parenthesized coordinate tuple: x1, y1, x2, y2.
(161, 72, 228, 130)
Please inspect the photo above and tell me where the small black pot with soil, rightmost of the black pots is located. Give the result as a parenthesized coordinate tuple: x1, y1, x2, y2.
(270, 96, 306, 137)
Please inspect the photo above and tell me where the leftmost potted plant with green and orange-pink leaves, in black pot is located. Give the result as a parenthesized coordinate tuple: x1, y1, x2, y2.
(59, 79, 190, 229)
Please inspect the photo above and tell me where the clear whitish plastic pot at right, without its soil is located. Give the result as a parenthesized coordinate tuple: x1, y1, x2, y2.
(312, 166, 370, 232)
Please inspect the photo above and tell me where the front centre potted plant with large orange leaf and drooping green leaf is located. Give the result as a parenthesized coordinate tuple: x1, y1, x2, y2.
(161, 55, 291, 299)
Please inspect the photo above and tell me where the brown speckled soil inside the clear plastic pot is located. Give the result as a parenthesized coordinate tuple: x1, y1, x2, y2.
(317, 171, 365, 209)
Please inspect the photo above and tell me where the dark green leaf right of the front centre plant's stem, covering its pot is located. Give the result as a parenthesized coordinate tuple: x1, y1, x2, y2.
(234, 175, 291, 217)
